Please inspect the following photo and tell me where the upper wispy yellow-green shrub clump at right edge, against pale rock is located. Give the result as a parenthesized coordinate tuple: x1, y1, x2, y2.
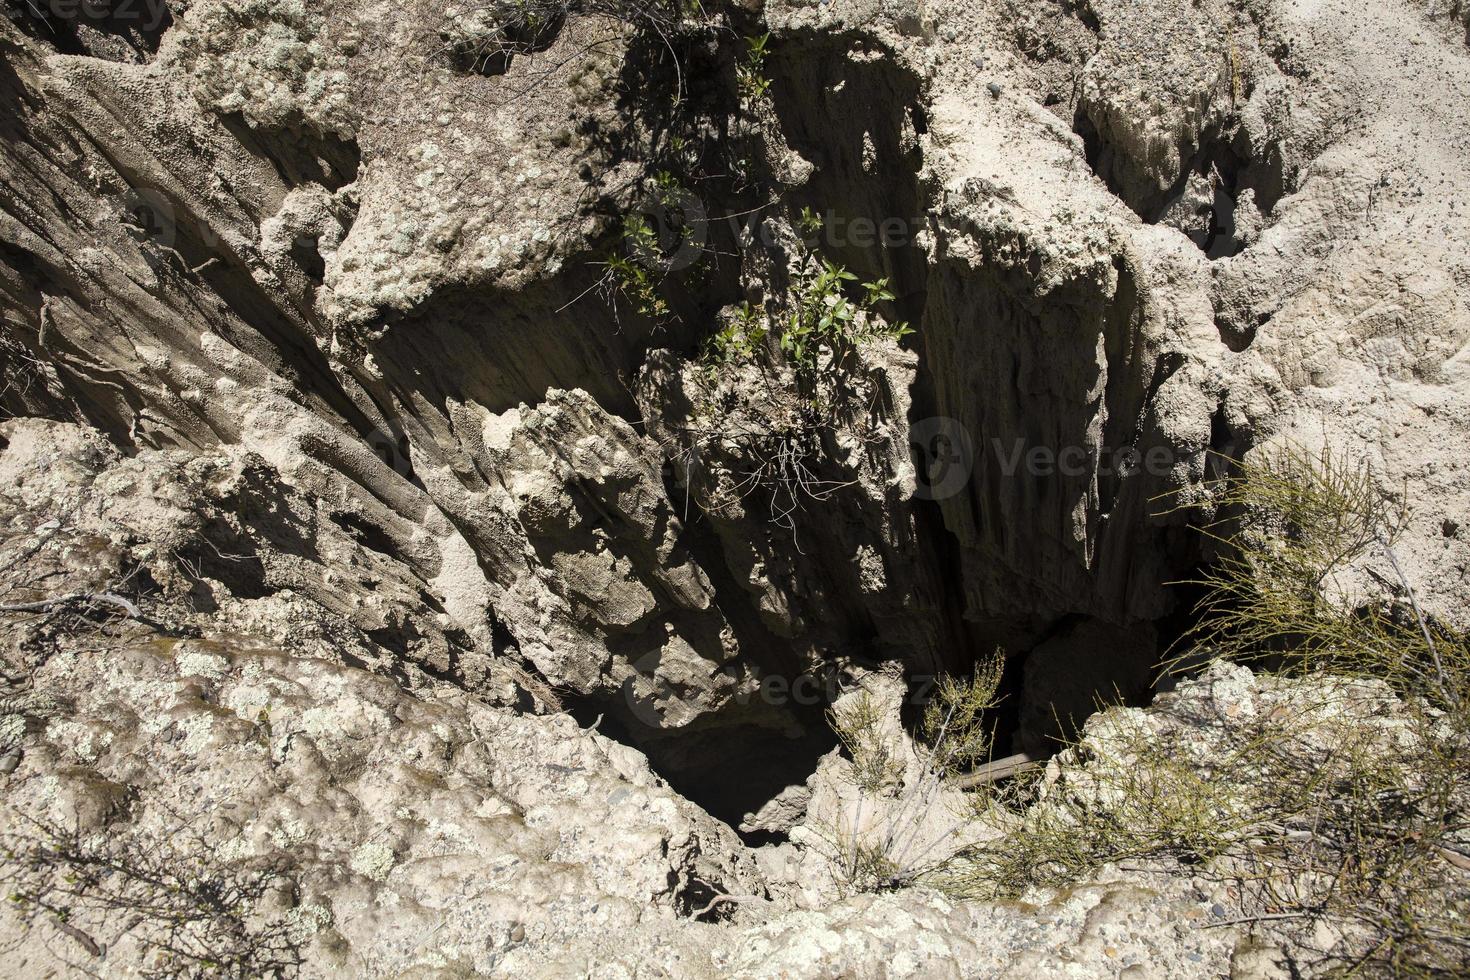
(1189, 445, 1470, 716)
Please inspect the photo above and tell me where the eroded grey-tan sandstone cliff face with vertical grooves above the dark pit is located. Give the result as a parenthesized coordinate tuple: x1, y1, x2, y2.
(0, 0, 1470, 968)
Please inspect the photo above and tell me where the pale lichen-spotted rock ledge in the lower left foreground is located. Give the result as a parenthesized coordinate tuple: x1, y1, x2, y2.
(0, 625, 760, 977)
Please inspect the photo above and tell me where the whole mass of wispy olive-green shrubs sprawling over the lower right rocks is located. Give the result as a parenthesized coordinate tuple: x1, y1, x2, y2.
(944, 447, 1470, 976)
